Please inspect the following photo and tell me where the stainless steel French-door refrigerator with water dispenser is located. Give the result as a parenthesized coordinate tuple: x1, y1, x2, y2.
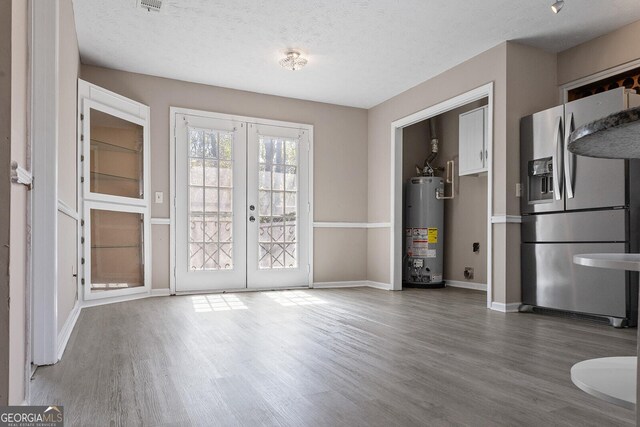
(520, 88, 640, 327)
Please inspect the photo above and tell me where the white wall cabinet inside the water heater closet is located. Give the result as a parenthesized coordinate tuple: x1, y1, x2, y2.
(458, 106, 489, 176)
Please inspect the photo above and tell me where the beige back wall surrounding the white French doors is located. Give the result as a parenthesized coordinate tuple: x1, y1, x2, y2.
(81, 65, 367, 289)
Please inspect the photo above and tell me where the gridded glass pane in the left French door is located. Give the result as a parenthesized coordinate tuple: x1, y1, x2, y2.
(187, 128, 234, 271)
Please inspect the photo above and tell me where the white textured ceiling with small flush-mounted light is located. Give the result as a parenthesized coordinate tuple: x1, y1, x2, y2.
(74, 0, 640, 108)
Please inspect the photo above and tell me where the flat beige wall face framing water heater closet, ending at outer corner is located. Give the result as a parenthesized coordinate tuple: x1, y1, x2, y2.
(367, 43, 508, 301)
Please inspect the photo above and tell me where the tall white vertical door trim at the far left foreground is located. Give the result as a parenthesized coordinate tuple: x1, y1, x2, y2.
(29, 1, 59, 365)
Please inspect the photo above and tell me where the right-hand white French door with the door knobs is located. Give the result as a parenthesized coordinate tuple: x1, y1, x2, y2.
(247, 124, 310, 288)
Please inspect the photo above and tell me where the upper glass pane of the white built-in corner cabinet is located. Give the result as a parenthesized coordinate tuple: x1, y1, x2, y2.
(89, 108, 144, 199)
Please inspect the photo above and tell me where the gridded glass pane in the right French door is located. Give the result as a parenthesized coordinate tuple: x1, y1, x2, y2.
(257, 135, 299, 270)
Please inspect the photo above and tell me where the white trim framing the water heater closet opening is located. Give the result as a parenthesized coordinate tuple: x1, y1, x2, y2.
(389, 82, 494, 308)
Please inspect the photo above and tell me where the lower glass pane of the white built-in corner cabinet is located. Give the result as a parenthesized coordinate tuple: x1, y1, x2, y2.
(91, 209, 144, 291)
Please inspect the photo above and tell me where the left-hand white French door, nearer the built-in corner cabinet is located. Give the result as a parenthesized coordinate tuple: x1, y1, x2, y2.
(175, 114, 247, 292)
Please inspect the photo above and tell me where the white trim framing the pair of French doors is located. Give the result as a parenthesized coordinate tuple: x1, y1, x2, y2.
(169, 106, 314, 295)
